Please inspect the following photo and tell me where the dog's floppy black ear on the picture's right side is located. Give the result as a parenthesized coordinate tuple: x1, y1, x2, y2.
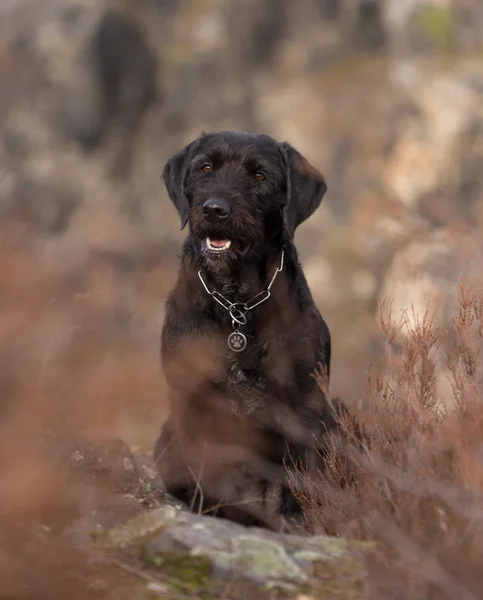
(280, 142, 327, 239)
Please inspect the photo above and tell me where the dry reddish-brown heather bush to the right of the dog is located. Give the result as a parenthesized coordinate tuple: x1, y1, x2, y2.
(294, 282, 483, 600)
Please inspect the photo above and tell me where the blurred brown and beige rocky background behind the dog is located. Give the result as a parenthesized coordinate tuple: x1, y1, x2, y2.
(0, 0, 483, 448)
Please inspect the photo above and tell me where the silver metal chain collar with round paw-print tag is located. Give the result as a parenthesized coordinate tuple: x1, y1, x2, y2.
(198, 250, 284, 352)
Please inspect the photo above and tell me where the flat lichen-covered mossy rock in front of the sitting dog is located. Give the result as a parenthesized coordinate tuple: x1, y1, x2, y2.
(98, 506, 374, 600)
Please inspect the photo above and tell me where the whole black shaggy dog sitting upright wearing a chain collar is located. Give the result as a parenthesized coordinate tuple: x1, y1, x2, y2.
(155, 132, 344, 527)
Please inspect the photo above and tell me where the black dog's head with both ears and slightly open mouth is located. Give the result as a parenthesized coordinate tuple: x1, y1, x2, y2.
(163, 132, 327, 266)
